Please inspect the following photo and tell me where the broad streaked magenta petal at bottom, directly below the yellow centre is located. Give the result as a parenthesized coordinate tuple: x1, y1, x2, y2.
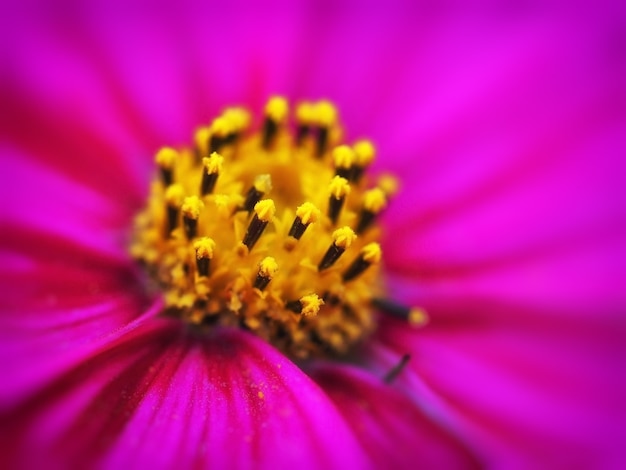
(0, 320, 366, 468)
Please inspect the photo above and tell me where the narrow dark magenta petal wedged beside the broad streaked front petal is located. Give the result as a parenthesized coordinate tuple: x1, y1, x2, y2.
(313, 366, 478, 469)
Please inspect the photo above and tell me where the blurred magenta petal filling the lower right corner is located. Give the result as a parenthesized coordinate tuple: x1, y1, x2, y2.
(375, 322, 626, 468)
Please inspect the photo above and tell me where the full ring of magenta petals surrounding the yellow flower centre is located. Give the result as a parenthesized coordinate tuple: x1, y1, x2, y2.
(0, 2, 624, 468)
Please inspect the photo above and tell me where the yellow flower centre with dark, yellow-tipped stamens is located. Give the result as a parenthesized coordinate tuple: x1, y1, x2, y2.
(131, 97, 424, 358)
